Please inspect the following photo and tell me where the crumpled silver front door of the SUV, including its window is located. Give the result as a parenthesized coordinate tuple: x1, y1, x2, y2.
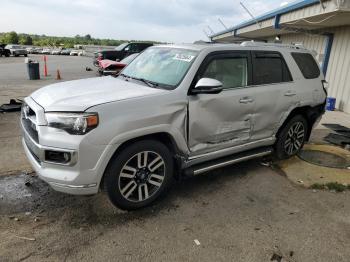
(188, 51, 254, 155)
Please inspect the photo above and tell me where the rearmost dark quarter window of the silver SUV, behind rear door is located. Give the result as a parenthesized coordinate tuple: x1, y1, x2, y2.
(292, 53, 320, 79)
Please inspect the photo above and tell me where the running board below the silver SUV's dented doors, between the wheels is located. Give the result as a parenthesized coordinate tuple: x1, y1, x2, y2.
(184, 147, 273, 176)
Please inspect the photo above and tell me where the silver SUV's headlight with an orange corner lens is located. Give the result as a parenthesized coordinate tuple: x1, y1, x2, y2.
(45, 113, 98, 135)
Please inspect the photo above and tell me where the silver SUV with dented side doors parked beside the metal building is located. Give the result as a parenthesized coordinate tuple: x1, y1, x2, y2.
(21, 42, 326, 210)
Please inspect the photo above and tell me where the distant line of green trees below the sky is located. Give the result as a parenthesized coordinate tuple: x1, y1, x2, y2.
(0, 31, 157, 48)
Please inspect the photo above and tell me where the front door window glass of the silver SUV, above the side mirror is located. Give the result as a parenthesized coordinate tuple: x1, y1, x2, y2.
(202, 57, 248, 88)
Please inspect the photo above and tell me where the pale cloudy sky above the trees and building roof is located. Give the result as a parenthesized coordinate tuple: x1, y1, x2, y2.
(0, 0, 286, 43)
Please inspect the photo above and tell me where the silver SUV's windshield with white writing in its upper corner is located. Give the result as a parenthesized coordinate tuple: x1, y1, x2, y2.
(121, 47, 197, 87)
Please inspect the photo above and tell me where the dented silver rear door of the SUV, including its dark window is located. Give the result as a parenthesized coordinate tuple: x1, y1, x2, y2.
(250, 51, 298, 140)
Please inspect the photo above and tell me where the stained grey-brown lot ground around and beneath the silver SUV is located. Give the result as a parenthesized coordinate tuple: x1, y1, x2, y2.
(0, 54, 350, 262)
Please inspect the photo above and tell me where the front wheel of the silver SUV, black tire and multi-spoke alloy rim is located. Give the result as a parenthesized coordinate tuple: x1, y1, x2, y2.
(104, 140, 174, 210)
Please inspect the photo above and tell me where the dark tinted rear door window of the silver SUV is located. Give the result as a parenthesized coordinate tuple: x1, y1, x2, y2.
(253, 52, 292, 85)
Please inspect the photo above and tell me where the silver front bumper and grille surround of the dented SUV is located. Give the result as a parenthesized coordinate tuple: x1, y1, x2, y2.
(21, 98, 117, 195)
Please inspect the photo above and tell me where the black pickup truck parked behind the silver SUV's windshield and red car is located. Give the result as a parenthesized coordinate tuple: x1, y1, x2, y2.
(93, 43, 153, 66)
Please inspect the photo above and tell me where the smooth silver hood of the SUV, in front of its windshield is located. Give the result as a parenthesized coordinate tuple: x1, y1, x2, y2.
(31, 76, 168, 112)
